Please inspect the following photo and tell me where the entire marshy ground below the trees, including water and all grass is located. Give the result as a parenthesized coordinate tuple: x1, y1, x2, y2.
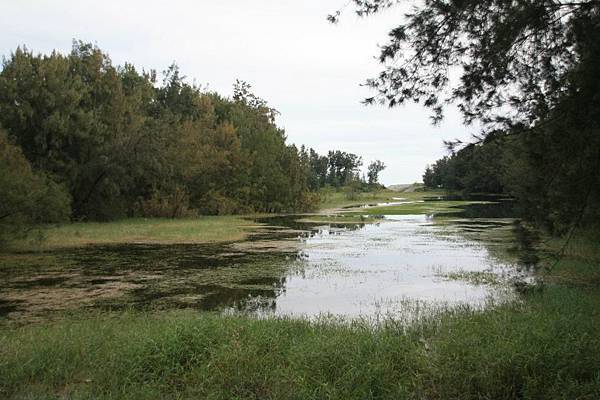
(0, 193, 600, 399)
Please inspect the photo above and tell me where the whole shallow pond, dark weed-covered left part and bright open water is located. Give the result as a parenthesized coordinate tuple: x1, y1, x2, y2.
(0, 199, 532, 320)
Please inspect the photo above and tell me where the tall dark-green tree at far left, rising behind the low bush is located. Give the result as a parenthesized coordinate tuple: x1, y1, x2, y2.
(0, 42, 153, 219)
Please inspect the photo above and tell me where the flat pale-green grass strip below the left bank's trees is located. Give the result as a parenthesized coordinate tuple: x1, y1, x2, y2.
(11, 216, 257, 251)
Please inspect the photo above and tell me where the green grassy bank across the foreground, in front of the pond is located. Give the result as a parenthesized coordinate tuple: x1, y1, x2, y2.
(0, 276, 600, 399)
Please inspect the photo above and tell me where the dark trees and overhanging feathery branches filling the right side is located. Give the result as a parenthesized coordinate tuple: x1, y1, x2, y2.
(330, 0, 600, 232)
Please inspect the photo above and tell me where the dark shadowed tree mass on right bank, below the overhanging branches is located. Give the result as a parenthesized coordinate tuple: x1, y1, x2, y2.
(423, 114, 600, 233)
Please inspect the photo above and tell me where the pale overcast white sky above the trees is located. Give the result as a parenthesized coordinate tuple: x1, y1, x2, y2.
(0, 0, 474, 185)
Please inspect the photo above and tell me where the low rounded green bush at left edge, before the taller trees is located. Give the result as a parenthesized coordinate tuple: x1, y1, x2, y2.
(0, 130, 70, 245)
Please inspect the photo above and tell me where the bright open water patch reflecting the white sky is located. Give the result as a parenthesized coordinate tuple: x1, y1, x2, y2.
(260, 215, 513, 317)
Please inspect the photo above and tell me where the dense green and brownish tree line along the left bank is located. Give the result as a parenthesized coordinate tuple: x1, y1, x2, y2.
(0, 42, 384, 241)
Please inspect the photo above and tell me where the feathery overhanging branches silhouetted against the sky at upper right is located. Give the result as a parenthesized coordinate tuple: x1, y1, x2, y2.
(329, 0, 600, 126)
